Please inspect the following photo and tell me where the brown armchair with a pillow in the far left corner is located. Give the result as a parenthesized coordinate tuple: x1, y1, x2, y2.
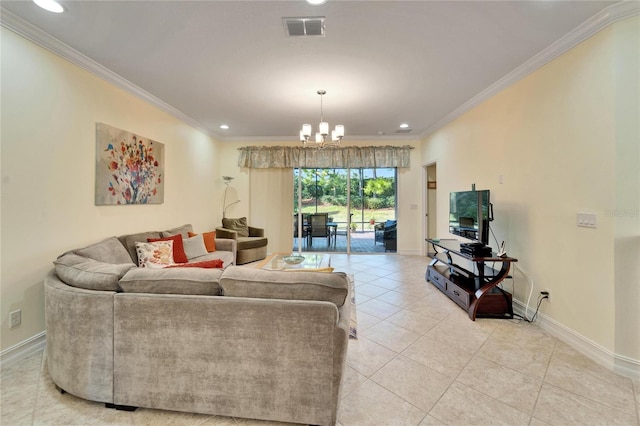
(216, 217, 269, 265)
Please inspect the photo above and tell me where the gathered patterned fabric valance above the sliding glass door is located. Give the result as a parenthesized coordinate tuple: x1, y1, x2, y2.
(238, 145, 413, 169)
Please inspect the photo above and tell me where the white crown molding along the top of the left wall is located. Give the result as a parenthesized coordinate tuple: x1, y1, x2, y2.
(0, 6, 220, 139)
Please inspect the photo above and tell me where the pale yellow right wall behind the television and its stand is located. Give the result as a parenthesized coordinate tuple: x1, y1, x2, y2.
(422, 19, 640, 360)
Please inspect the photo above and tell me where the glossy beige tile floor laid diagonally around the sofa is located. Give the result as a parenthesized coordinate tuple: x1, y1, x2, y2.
(0, 254, 640, 426)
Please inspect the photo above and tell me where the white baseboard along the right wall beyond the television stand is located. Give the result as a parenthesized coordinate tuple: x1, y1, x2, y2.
(513, 299, 640, 379)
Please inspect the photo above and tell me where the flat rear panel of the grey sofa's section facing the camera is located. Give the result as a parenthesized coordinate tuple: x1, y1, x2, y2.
(113, 293, 346, 425)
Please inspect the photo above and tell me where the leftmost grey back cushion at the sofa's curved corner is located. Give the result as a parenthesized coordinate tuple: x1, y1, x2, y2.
(53, 253, 138, 291)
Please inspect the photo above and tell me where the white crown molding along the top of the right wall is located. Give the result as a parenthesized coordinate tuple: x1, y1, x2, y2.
(420, 0, 640, 139)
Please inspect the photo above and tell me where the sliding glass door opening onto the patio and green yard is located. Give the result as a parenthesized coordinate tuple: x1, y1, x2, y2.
(292, 168, 397, 253)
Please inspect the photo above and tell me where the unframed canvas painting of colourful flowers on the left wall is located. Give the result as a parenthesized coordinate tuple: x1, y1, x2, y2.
(95, 123, 164, 206)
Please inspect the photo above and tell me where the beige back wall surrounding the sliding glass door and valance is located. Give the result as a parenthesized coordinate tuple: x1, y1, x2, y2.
(220, 141, 424, 254)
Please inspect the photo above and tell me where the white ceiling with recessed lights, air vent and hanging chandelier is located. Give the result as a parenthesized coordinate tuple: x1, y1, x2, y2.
(2, 0, 616, 140)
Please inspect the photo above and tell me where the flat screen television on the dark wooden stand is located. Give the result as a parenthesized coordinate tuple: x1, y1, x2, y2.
(449, 189, 493, 245)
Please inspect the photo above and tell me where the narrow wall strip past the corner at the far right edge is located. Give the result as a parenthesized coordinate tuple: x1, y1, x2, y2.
(606, 17, 640, 360)
